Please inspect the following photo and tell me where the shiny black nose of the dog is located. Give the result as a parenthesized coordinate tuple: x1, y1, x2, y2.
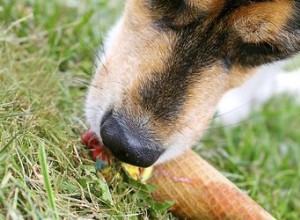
(100, 115, 164, 167)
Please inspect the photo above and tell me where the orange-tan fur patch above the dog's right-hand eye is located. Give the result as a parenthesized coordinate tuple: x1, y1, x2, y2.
(229, 0, 293, 43)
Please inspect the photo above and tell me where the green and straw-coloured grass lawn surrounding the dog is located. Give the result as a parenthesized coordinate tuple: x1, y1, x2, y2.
(0, 0, 300, 219)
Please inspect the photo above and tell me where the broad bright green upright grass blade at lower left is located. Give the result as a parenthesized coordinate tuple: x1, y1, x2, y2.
(39, 146, 59, 220)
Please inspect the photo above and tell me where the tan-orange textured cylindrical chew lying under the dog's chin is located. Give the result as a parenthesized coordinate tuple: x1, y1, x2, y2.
(148, 150, 274, 220)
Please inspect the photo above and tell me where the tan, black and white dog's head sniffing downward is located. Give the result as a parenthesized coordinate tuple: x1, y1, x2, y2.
(86, 0, 300, 167)
